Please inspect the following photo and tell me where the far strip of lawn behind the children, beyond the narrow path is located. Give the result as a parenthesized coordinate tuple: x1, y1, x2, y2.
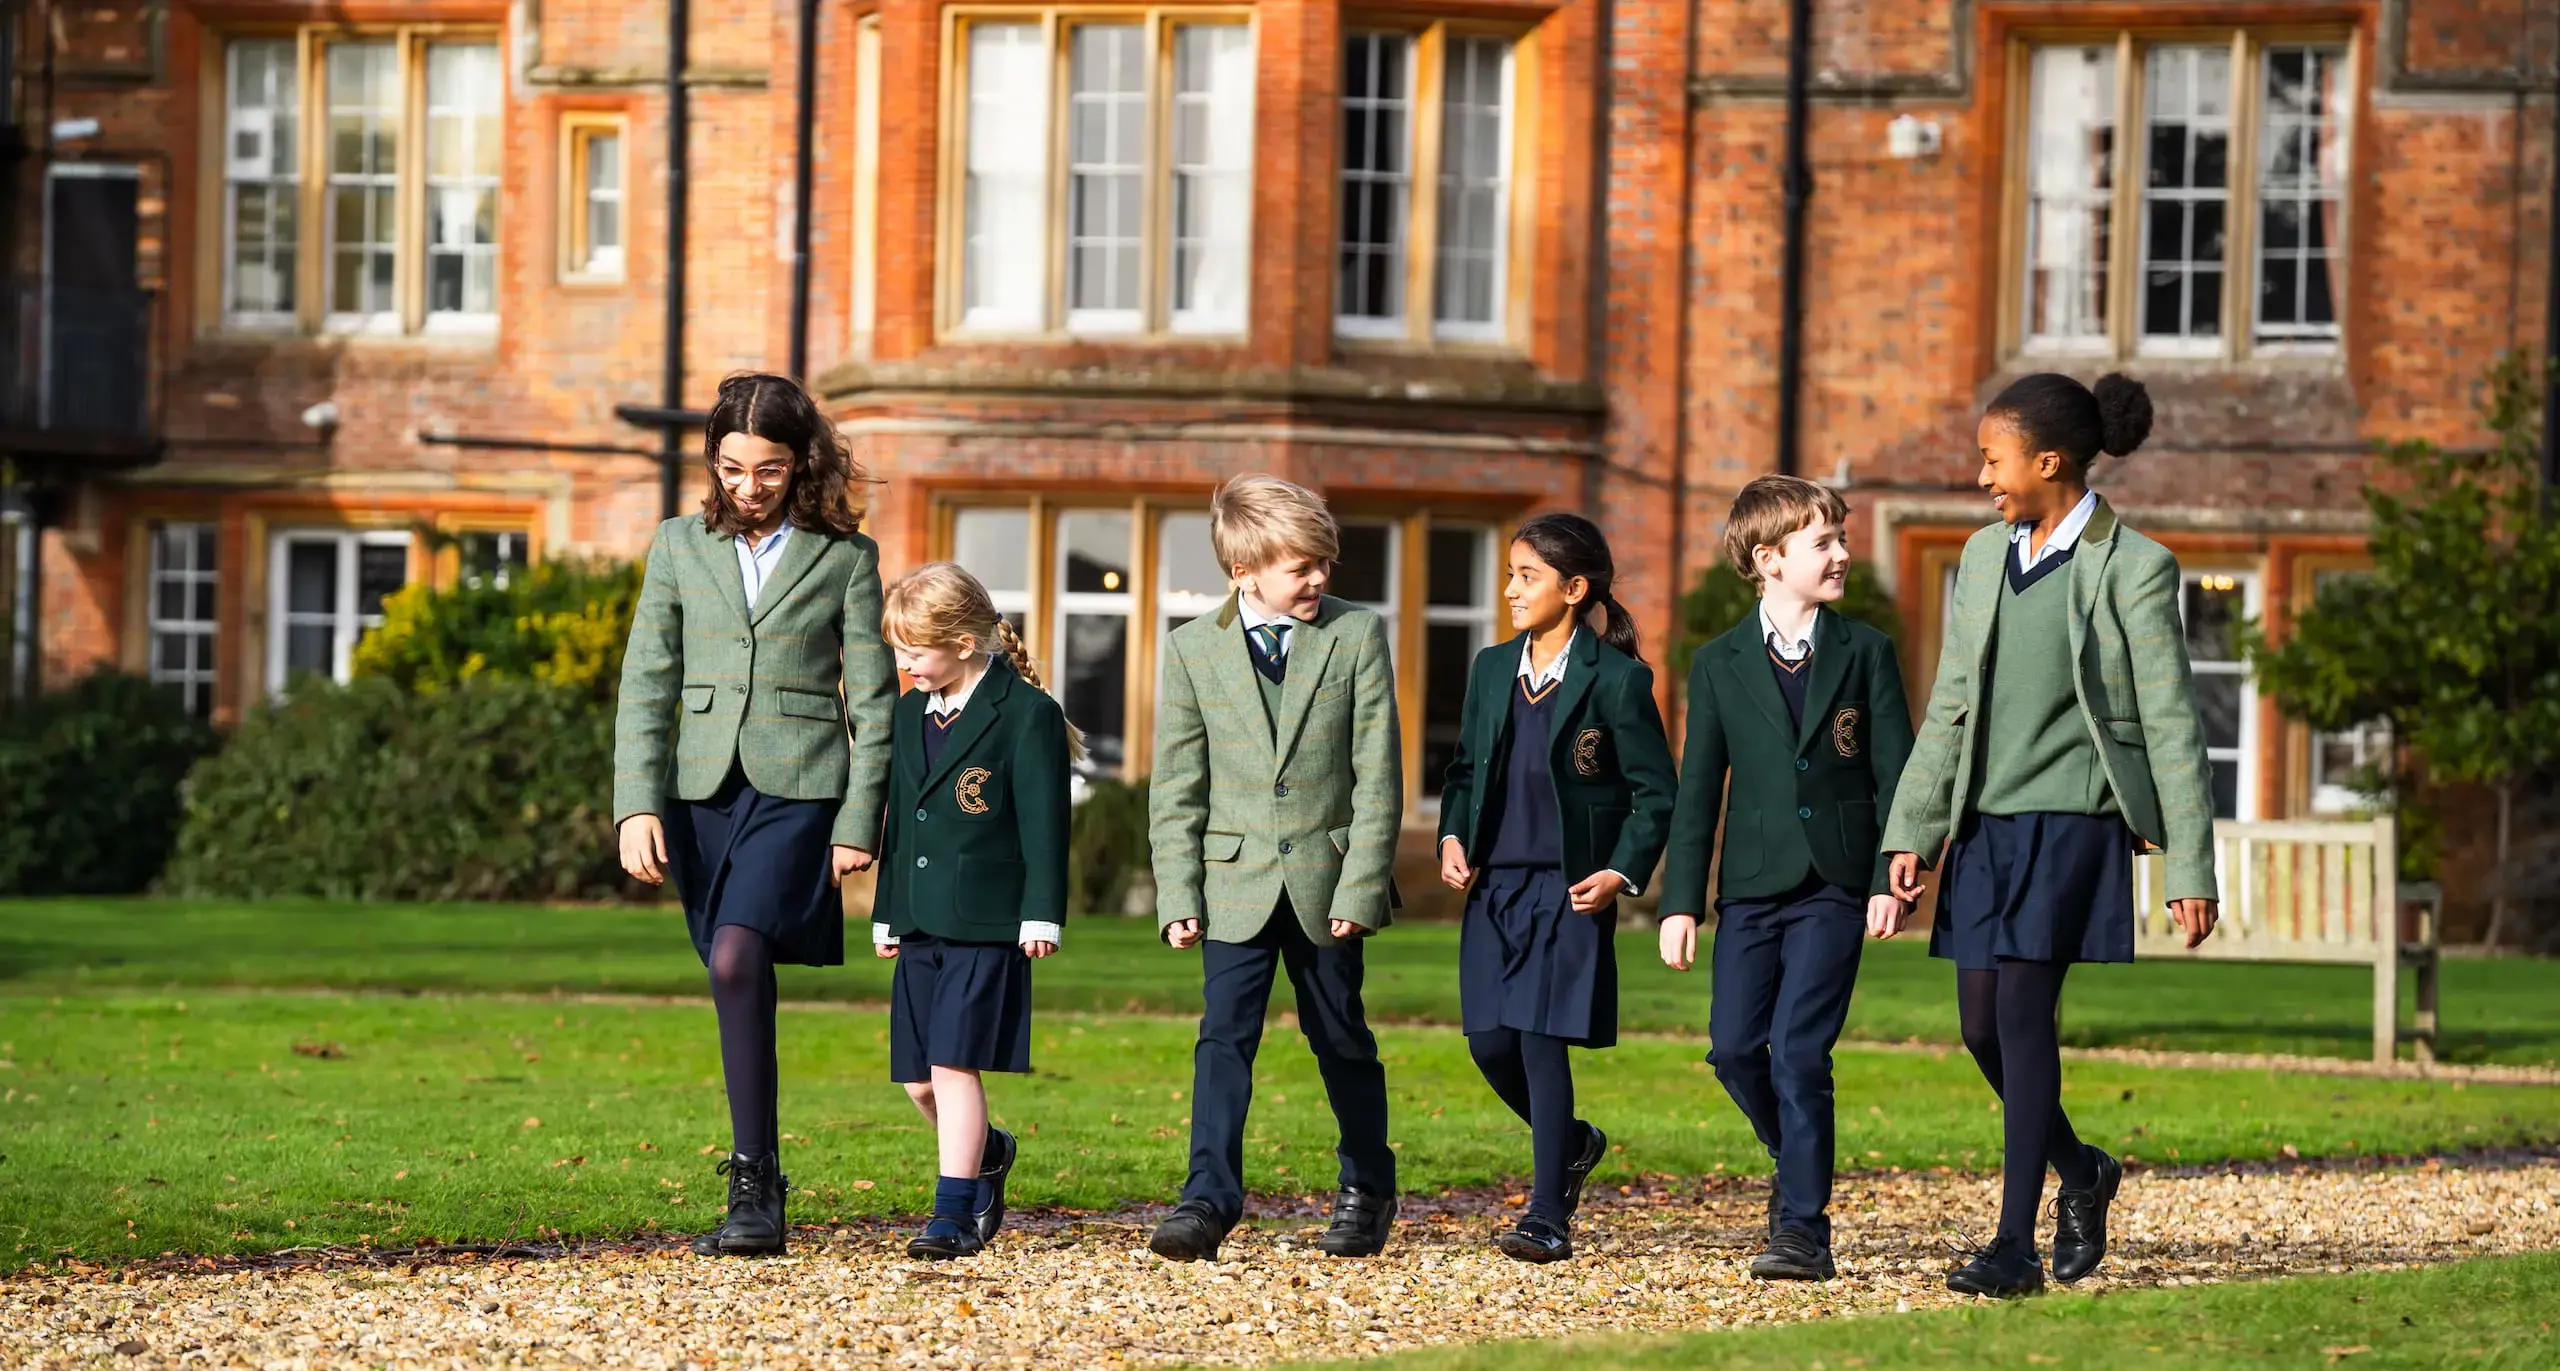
(0, 900, 2560, 1064)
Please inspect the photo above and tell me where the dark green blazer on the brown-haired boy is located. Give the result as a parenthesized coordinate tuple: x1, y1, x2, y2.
(1661, 606, 1912, 913)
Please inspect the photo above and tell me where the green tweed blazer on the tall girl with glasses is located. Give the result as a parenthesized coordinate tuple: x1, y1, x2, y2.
(614, 514, 896, 852)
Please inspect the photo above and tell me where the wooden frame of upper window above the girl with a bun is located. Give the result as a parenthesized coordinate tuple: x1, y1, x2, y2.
(1994, 23, 2363, 368)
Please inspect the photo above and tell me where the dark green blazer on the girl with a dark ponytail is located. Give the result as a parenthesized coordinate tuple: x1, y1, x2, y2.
(1441, 629, 1679, 888)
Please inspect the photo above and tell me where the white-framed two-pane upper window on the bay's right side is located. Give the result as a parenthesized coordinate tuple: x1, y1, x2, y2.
(1334, 23, 1518, 343)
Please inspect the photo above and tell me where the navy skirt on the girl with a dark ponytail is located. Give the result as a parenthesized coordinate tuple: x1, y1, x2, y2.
(1457, 867, 1618, 1046)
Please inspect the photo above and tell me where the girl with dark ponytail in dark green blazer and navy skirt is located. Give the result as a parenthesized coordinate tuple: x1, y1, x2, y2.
(1441, 514, 1677, 1261)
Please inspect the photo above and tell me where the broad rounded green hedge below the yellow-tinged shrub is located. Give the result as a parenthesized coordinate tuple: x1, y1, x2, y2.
(166, 675, 635, 900)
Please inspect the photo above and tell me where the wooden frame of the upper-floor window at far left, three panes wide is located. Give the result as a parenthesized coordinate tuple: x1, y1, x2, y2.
(197, 23, 512, 340)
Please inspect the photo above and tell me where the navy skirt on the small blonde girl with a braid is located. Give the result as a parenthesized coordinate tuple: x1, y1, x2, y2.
(888, 934, 1032, 1085)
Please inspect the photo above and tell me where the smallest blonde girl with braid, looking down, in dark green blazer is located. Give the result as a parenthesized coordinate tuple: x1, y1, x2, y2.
(870, 563, 1085, 1261)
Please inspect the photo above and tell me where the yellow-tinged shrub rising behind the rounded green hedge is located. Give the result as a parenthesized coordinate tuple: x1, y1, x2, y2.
(353, 560, 640, 706)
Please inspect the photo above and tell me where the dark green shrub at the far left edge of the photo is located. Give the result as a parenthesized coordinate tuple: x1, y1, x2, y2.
(0, 670, 215, 895)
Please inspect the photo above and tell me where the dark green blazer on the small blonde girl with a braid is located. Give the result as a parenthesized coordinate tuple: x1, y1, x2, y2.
(870, 657, 1073, 944)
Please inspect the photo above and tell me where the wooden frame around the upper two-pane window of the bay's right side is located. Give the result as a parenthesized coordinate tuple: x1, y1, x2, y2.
(1326, 10, 1541, 356)
